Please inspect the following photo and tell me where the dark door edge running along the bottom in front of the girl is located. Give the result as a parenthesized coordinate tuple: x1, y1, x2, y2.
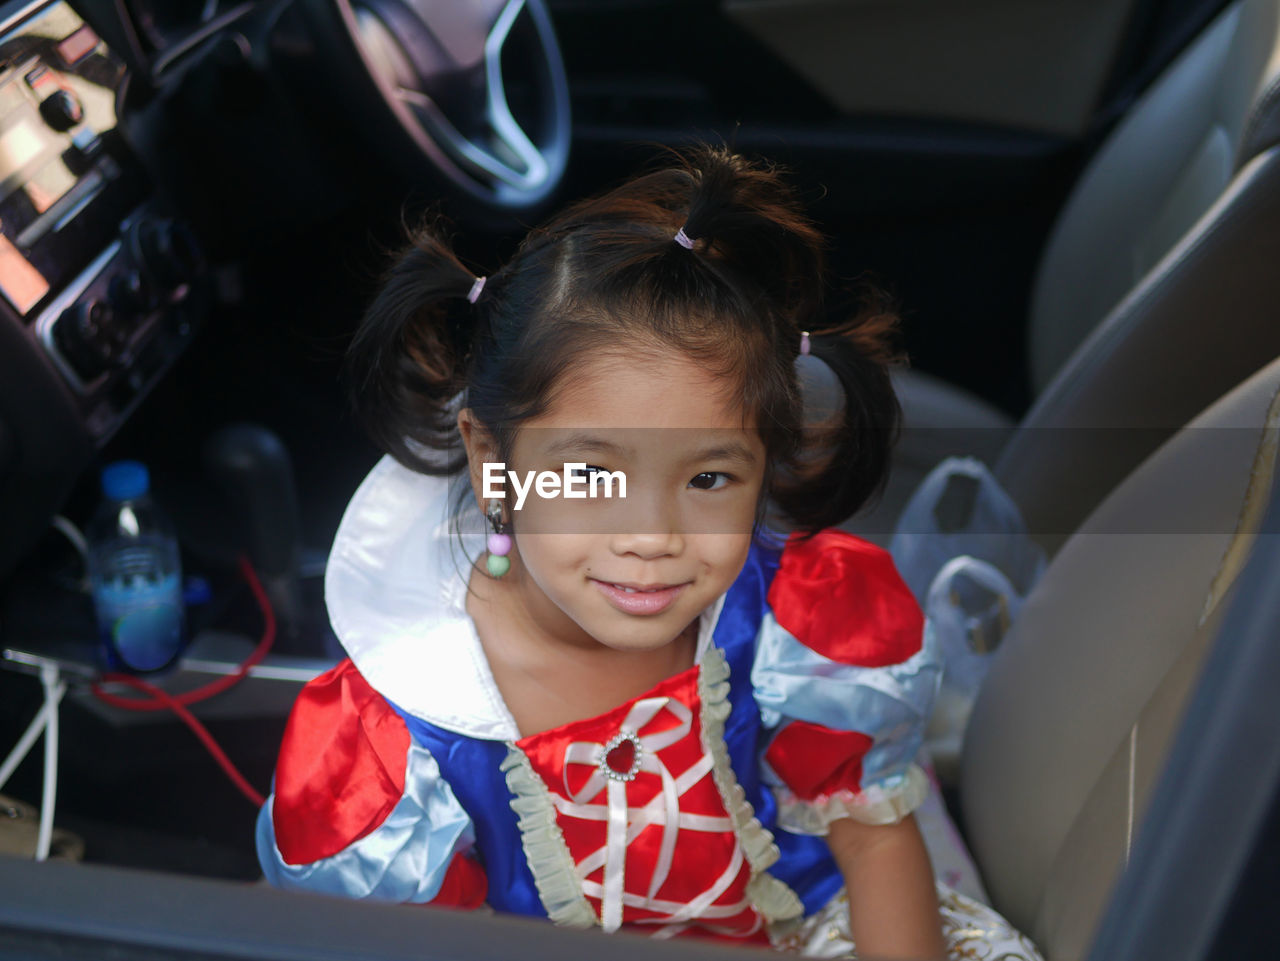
(0, 857, 788, 961)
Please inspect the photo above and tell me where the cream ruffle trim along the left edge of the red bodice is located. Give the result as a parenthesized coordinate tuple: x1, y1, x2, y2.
(500, 743, 600, 928)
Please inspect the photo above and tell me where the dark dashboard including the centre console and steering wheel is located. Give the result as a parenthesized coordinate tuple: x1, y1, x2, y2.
(0, 0, 570, 578)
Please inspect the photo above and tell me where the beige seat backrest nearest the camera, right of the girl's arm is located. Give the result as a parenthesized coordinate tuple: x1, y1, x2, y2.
(960, 360, 1280, 961)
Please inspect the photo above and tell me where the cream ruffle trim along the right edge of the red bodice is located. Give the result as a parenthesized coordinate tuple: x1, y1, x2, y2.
(698, 645, 804, 933)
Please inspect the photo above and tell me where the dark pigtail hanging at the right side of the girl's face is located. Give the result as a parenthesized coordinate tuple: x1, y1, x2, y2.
(773, 288, 902, 532)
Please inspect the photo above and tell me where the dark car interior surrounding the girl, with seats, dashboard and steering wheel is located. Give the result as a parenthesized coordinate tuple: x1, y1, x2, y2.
(0, 0, 1280, 961)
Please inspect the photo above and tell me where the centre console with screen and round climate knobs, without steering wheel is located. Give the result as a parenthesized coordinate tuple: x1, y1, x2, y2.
(0, 0, 209, 576)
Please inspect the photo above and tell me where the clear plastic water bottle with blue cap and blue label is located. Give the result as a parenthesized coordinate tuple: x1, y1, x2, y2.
(86, 461, 186, 673)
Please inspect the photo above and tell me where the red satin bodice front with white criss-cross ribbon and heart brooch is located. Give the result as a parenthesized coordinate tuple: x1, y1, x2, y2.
(517, 667, 762, 938)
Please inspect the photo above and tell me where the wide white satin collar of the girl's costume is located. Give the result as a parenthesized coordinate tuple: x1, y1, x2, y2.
(324, 457, 724, 741)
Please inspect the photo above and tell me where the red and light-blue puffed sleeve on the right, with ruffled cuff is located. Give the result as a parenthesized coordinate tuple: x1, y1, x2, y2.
(751, 531, 941, 834)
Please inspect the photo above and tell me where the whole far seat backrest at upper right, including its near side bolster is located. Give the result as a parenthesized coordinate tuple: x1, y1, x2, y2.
(996, 0, 1280, 549)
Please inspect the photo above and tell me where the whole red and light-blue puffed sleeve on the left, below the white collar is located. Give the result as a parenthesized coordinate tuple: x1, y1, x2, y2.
(257, 662, 488, 907)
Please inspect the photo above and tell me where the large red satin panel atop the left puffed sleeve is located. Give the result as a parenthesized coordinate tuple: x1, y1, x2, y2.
(271, 660, 410, 864)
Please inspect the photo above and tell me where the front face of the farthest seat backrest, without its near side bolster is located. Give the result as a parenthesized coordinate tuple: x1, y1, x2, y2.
(1028, 0, 1280, 394)
